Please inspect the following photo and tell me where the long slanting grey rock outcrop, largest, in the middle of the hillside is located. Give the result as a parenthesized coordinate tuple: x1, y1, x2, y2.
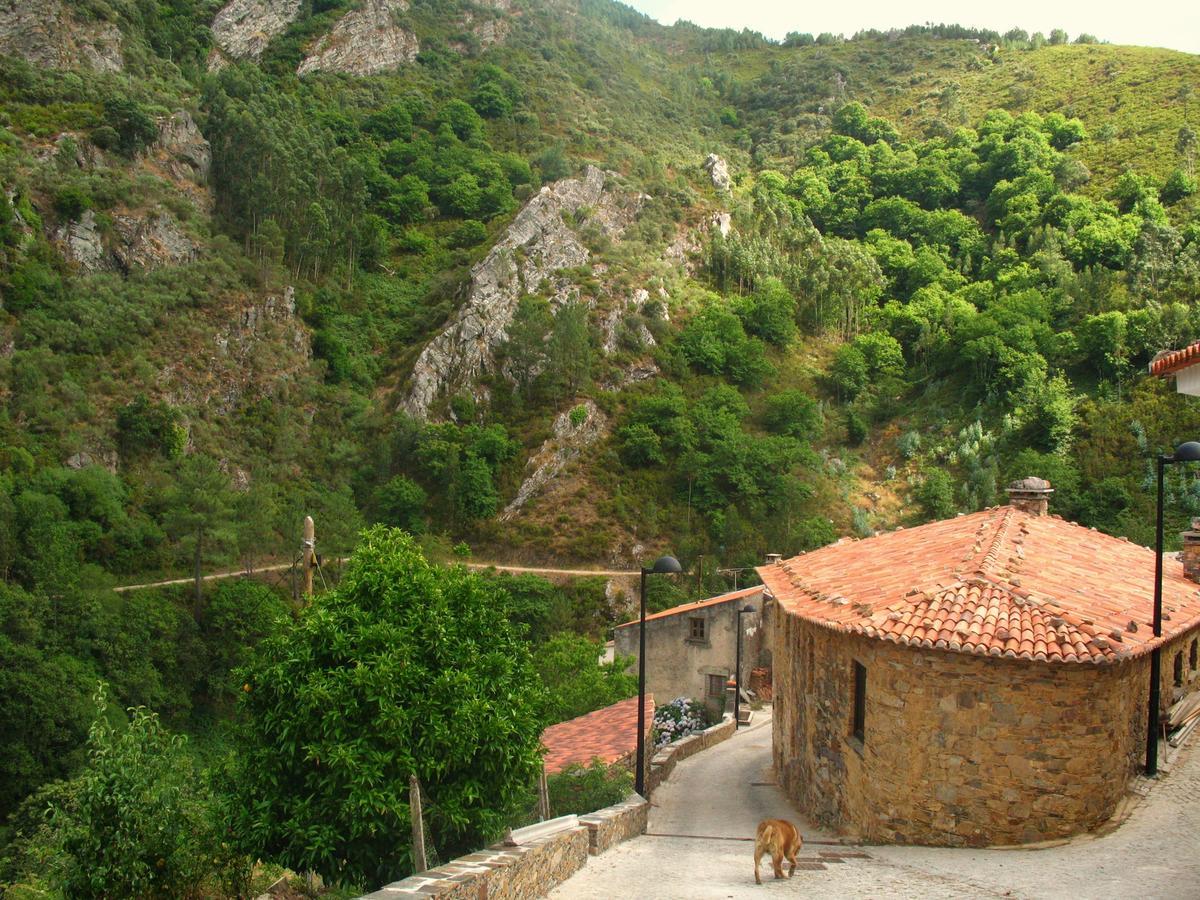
(401, 166, 642, 419)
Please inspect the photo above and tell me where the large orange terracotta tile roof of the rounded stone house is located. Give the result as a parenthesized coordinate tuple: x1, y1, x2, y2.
(758, 506, 1200, 664)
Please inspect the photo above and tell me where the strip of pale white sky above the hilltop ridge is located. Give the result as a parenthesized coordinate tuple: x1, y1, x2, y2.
(623, 0, 1200, 53)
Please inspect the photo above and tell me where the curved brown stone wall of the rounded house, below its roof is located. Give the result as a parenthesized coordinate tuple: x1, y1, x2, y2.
(773, 611, 1195, 846)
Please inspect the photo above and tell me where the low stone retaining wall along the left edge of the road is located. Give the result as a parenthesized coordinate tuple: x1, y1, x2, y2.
(366, 719, 734, 900)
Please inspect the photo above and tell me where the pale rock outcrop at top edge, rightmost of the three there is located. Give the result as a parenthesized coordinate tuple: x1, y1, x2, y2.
(296, 0, 421, 76)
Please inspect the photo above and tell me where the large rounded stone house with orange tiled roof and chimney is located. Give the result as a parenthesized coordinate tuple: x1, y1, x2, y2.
(758, 479, 1200, 846)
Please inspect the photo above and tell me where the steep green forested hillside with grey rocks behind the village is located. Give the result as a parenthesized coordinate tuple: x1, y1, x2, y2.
(0, 0, 1200, 892)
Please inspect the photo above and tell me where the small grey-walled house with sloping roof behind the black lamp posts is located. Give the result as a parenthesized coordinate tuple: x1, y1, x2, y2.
(613, 586, 763, 709)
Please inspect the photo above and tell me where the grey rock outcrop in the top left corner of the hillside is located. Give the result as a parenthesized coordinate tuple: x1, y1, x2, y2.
(0, 0, 125, 72)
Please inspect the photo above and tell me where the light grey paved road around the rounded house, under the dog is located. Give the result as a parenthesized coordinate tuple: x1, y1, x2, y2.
(551, 710, 1200, 900)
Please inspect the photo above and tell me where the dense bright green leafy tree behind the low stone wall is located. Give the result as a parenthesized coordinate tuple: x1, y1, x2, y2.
(234, 526, 541, 887)
